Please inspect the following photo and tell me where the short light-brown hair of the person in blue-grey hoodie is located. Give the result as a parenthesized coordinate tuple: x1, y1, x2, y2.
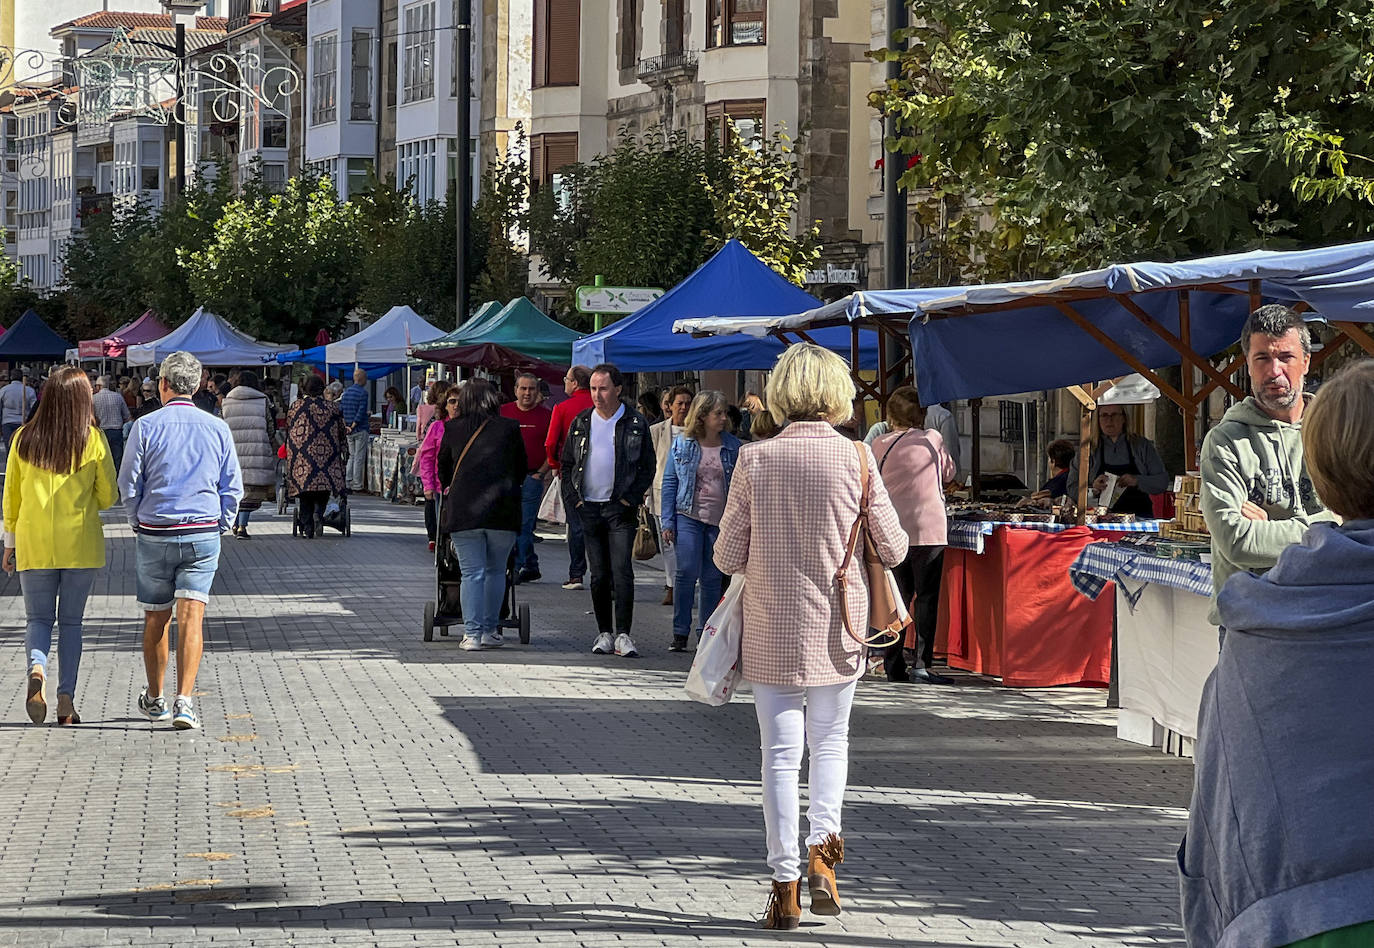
(1303, 359, 1374, 521)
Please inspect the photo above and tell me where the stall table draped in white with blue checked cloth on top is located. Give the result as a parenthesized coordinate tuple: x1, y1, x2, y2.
(1069, 543, 1217, 757)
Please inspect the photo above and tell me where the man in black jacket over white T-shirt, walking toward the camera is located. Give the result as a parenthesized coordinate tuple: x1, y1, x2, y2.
(559, 363, 654, 658)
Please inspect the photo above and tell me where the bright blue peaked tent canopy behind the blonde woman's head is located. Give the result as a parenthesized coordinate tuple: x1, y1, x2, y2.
(573, 240, 877, 372)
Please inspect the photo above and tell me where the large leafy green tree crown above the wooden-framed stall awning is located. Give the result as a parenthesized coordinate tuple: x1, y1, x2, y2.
(874, 0, 1374, 279)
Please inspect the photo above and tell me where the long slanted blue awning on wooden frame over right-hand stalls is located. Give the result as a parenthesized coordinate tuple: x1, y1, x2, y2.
(679, 242, 1374, 404)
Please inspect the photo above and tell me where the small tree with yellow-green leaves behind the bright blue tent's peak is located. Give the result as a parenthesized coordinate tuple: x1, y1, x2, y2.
(706, 125, 820, 286)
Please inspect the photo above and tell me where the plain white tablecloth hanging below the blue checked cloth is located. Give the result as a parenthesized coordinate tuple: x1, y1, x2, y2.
(1116, 583, 1217, 756)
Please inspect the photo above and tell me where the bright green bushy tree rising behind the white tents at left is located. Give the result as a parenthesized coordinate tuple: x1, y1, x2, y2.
(185, 177, 364, 343)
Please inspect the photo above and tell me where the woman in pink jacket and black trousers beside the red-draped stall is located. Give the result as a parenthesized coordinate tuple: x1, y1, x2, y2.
(872, 385, 954, 684)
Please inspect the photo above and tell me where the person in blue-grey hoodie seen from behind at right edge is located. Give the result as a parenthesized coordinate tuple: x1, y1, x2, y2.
(1178, 360, 1374, 948)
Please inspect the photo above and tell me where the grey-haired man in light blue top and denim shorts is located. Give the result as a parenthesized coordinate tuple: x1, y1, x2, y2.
(120, 352, 243, 731)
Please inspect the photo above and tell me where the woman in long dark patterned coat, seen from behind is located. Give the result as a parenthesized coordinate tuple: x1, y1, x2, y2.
(286, 375, 348, 539)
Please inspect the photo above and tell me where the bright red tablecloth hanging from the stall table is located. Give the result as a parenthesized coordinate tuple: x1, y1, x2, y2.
(936, 526, 1118, 688)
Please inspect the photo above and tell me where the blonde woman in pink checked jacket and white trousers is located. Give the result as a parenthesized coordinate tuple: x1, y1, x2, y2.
(716, 343, 908, 929)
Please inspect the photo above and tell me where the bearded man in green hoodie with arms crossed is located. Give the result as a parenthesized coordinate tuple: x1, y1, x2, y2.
(1201, 304, 1334, 635)
